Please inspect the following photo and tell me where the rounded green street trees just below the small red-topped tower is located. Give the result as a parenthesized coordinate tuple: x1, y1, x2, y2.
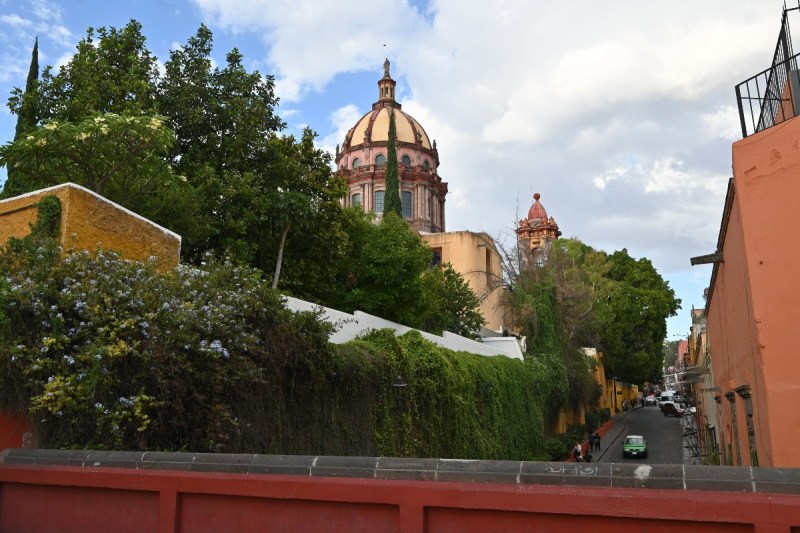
(506, 239, 680, 403)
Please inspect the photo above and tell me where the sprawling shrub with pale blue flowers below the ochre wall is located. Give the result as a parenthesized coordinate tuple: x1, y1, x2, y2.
(0, 208, 334, 451)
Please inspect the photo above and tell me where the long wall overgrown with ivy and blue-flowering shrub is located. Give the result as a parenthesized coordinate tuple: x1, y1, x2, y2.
(0, 194, 566, 460)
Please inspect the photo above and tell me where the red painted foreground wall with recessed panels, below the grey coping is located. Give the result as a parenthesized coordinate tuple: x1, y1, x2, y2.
(0, 465, 800, 533)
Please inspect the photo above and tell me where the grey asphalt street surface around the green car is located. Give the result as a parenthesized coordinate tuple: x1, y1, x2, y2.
(593, 406, 684, 464)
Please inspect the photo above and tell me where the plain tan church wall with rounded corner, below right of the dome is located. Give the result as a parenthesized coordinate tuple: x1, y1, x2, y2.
(420, 231, 511, 331)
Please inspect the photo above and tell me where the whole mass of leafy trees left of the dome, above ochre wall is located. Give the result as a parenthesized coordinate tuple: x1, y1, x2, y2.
(3, 21, 346, 282)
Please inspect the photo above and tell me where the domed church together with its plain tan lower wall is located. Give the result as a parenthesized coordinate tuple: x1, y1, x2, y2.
(335, 59, 522, 334)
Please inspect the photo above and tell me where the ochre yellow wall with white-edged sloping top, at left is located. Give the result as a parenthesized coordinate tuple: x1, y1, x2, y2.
(0, 183, 181, 271)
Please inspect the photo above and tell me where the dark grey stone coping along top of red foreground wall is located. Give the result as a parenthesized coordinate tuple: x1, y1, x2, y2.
(0, 448, 800, 494)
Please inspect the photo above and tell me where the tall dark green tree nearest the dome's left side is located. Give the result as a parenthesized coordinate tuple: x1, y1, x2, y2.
(158, 26, 345, 268)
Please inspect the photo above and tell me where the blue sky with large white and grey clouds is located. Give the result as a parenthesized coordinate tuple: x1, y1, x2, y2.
(0, 0, 793, 339)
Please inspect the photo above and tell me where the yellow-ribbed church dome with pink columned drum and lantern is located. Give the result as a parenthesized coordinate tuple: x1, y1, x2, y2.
(335, 59, 447, 233)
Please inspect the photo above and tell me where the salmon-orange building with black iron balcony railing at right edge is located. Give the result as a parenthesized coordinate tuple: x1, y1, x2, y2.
(692, 8, 800, 467)
